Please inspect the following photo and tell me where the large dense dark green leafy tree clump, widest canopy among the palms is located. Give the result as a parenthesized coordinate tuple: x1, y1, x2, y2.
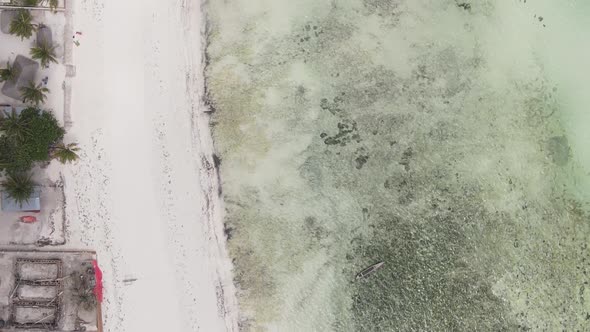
(0, 107, 65, 173)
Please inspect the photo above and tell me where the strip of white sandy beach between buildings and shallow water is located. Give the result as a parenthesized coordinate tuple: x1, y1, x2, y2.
(64, 0, 238, 332)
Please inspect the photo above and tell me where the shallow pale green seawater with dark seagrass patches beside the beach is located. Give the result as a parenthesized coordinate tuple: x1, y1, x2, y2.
(206, 0, 590, 331)
